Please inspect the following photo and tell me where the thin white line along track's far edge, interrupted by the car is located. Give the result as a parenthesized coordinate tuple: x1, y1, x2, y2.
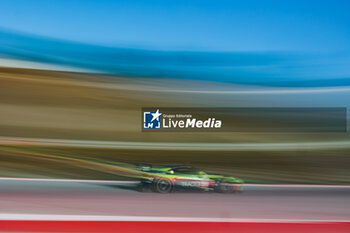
(0, 177, 350, 188)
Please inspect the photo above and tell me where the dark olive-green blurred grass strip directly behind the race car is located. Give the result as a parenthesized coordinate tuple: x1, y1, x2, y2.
(0, 146, 350, 184)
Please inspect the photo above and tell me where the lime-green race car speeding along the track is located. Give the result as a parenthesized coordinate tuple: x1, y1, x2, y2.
(135, 165, 243, 193)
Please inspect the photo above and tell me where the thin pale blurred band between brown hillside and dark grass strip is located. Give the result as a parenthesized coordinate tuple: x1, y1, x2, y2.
(0, 137, 350, 151)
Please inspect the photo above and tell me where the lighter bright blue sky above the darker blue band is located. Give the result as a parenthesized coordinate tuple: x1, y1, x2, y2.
(0, 0, 350, 53)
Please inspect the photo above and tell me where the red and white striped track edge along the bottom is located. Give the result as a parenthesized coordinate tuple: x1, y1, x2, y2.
(0, 214, 350, 233)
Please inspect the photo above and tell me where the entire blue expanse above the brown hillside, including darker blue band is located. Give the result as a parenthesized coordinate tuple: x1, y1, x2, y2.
(0, 0, 350, 87)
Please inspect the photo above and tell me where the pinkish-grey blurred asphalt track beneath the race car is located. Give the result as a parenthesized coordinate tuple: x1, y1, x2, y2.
(0, 179, 350, 221)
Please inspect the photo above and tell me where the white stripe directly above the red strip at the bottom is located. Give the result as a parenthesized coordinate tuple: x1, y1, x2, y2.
(0, 213, 350, 223)
